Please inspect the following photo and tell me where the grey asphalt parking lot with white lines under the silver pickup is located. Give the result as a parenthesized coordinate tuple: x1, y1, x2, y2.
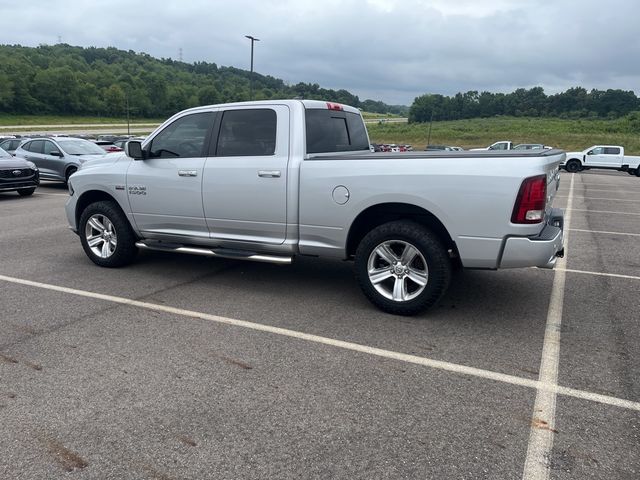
(0, 172, 640, 480)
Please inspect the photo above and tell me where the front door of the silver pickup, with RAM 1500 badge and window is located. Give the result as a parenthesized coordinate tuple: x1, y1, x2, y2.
(126, 112, 215, 242)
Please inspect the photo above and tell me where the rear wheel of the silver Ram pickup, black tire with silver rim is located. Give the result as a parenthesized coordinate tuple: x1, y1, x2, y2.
(355, 220, 452, 315)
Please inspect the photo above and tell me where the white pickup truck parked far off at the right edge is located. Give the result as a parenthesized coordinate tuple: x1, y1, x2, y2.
(560, 145, 640, 177)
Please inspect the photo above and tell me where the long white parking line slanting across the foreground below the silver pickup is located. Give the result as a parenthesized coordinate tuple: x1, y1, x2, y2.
(0, 268, 640, 412)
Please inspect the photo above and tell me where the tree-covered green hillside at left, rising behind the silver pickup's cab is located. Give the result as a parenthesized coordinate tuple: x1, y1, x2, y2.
(0, 44, 409, 118)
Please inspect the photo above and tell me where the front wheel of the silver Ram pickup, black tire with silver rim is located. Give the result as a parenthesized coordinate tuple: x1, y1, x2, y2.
(78, 201, 138, 268)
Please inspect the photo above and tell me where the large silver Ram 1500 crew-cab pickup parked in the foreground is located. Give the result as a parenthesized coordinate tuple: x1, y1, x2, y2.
(66, 100, 564, 315)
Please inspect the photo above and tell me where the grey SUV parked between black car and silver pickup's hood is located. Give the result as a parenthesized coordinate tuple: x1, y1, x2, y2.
(15, 137, 107, 183)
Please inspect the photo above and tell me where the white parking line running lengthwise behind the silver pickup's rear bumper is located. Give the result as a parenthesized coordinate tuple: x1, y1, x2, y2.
(522, 177, 575, 480)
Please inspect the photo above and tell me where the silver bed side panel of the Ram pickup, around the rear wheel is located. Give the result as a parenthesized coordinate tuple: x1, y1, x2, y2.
(299, 151, 563, 268)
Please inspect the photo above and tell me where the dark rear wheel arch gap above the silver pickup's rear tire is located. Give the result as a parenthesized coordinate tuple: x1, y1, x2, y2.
(346, 203, 459, 258)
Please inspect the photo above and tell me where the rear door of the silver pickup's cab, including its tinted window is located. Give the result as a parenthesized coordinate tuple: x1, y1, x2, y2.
(202, 105, 289, 244)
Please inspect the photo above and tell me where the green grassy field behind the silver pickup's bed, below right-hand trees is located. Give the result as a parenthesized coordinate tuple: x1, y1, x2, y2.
(367, 117, 640, 155)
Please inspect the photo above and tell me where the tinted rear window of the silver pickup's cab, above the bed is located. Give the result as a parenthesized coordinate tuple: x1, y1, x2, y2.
(305, 109, 369, 153)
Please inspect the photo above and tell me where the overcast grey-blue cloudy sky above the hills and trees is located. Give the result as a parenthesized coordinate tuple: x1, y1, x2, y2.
(0, 0, 640, 105)
